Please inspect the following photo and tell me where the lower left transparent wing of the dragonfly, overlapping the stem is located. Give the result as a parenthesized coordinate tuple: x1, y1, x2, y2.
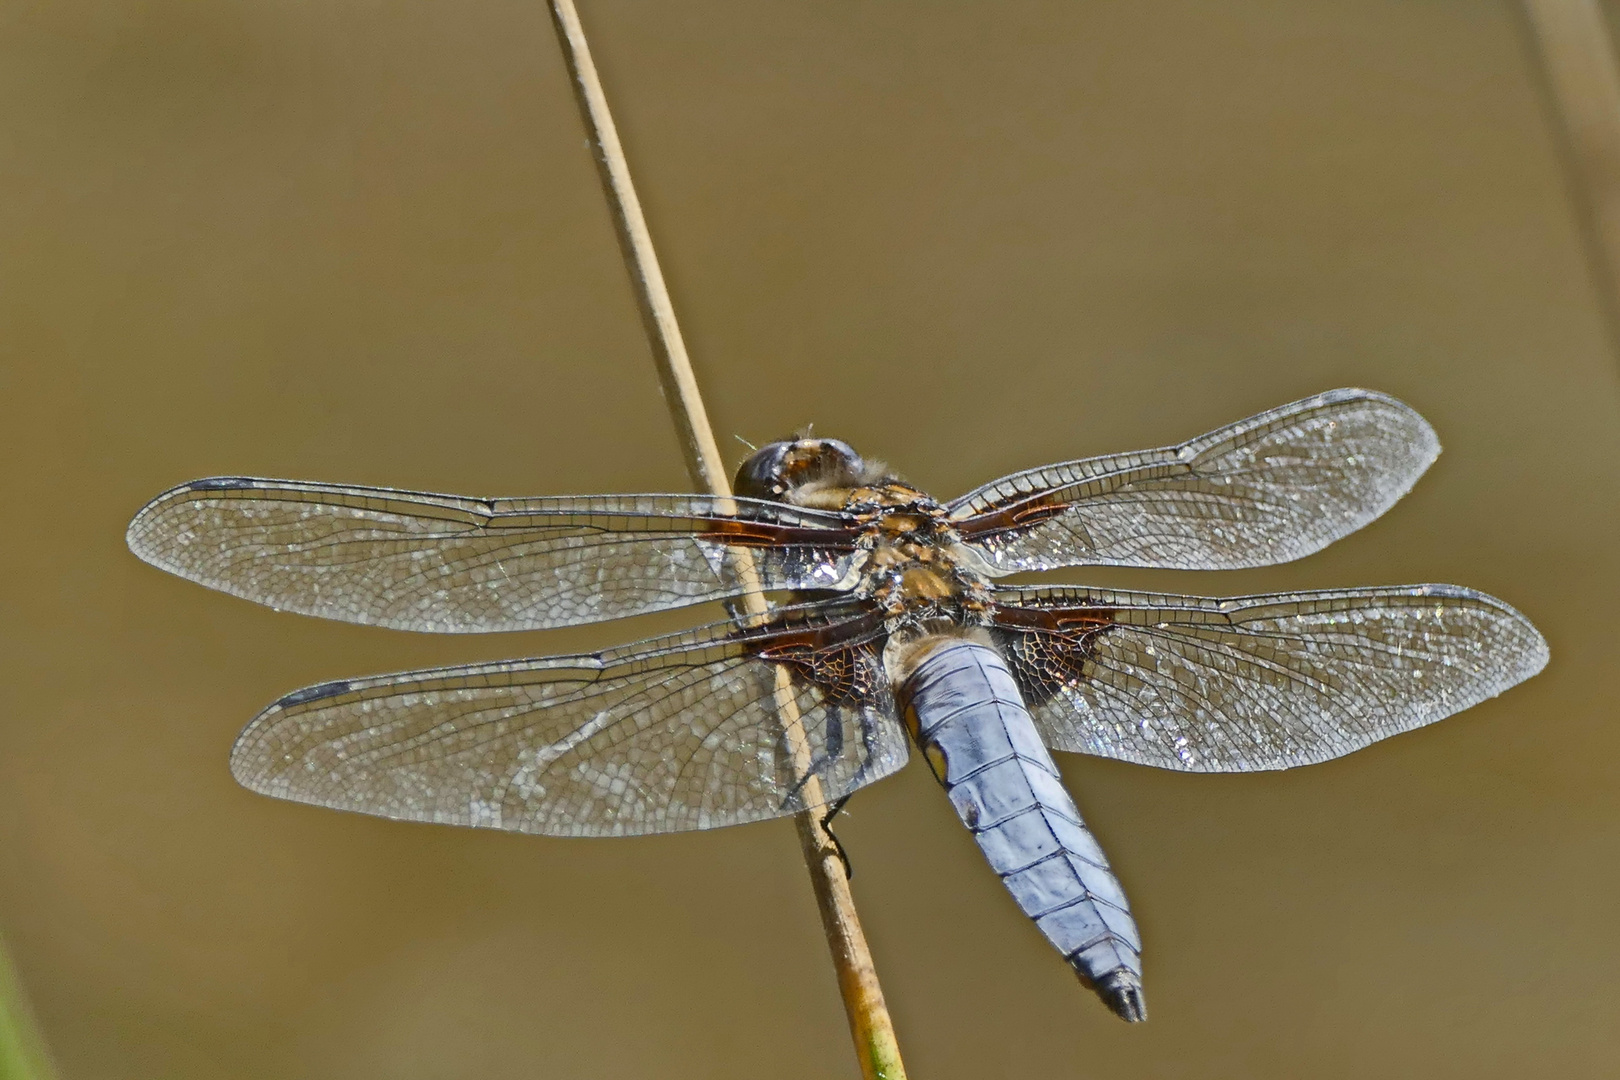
(230, 612, 906, 836)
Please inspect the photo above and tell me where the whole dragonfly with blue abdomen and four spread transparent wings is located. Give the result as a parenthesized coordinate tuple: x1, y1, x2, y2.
(126, 389, 1547, 1020)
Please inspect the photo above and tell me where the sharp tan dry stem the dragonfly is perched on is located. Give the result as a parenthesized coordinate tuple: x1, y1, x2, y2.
(551, 0, 906, 1080)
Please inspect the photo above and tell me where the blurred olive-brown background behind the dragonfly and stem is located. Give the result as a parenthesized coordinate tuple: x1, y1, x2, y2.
(0, 0, 1620, 1080)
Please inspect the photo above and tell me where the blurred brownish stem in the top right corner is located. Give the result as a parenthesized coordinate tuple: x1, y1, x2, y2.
(1524, 0, 1620, 340)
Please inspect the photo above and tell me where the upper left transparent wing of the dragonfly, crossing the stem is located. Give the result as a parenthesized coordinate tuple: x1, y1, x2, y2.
(126, 478, 852, 633)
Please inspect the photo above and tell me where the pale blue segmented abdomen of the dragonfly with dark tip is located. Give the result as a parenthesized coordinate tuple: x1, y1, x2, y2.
(902, 641, 1145, 1020)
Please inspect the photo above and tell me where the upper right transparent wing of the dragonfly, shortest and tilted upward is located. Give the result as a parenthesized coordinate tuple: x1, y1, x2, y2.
(949, 390, 1440, 573)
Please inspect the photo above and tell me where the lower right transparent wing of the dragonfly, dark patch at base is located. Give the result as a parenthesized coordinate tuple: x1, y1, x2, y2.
(996, 585, 1547, 772)
